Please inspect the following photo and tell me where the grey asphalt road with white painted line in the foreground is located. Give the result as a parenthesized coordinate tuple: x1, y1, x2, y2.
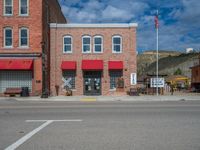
(0, 100, 200, 150)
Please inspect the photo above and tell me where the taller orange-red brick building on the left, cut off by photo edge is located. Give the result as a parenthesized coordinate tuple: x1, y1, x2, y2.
(0, 0, 66, 95)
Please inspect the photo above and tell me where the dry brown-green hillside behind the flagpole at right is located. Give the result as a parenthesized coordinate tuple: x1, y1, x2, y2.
(137, 53, 198, 77)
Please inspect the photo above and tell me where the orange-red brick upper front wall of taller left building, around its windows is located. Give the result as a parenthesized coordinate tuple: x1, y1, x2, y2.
(0, 0, 42, 53)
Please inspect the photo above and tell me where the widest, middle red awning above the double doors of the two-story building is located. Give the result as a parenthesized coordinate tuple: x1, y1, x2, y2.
(82, 60, 103, 70)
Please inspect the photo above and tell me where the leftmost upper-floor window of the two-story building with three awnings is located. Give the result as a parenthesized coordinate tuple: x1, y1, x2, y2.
(63, 36, 72, 53)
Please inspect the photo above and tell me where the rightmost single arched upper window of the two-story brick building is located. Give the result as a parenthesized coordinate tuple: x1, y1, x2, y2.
(112, 36, 122, 53)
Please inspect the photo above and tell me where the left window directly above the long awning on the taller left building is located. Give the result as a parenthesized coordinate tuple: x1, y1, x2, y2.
(4, 27, 13, 47)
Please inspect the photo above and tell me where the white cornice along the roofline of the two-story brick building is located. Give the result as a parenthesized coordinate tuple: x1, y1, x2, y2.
(50, 23, 138, 28)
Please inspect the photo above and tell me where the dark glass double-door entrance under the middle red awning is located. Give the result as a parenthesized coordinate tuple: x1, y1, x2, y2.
(83, 71, 102, 95)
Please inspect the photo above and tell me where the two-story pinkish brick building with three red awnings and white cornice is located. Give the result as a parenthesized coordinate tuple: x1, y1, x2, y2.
(50, 23, 137, 95)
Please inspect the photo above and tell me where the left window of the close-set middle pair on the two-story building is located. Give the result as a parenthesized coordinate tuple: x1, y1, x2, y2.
(82, 36, 91, 53)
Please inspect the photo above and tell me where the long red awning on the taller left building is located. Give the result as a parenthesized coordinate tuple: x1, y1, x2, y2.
(0, 59, 33, 70)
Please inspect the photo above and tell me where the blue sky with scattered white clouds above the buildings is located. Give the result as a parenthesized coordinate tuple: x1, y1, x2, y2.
(60, 0, 200, 52)
